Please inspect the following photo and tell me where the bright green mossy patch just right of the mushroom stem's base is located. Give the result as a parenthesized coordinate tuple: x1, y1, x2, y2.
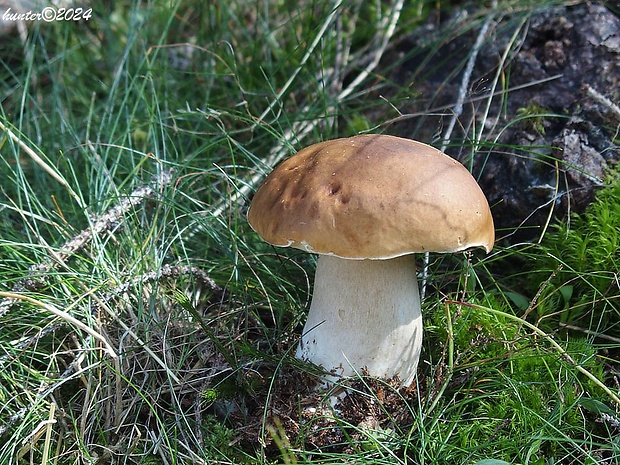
(427, 293, 604, 463)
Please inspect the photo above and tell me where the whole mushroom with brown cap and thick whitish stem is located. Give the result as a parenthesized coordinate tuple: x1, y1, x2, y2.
(248, 135, 495, 386)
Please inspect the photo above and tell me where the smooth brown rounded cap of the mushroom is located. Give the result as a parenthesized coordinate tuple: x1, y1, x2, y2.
(248, 135, 495, 259)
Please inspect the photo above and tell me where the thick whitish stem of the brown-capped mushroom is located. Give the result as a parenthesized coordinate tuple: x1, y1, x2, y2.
(296, 255, 422, 386)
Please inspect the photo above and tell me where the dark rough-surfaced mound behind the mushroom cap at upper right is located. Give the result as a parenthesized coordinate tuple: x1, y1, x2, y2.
(390, 2, 620, 242)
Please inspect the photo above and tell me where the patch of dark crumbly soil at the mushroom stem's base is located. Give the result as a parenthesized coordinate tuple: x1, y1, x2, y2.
(228, 365, 426, 455)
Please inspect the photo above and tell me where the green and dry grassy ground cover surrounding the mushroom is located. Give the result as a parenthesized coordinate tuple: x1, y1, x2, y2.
(0, 0, 620, 465)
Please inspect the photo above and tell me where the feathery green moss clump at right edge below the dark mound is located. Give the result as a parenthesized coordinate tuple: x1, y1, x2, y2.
(527, 173, 620, 337)
